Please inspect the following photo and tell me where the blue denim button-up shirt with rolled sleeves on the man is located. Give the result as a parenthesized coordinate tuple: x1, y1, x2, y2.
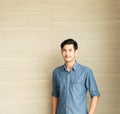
(52, 62, 100, 114)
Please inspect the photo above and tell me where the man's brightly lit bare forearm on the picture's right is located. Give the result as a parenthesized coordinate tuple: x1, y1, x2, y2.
(89, 96, 99, 114)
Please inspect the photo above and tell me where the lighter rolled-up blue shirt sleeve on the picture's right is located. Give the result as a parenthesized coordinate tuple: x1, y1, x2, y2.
(86, 68, 100, 98)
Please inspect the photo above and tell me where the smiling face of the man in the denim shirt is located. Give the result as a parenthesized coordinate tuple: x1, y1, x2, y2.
(61, 44, 77, 62)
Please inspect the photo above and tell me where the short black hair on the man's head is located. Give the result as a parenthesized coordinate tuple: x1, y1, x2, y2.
(60, 38, 78, 50)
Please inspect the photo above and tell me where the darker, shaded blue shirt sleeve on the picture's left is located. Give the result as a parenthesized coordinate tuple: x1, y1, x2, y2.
(52, 70, 59, 97)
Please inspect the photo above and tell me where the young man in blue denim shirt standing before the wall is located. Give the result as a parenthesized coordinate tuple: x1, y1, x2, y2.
(52, 39, 100, 114)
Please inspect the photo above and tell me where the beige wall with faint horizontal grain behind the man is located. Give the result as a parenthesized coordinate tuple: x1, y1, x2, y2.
(0, 0, 120, 114)
